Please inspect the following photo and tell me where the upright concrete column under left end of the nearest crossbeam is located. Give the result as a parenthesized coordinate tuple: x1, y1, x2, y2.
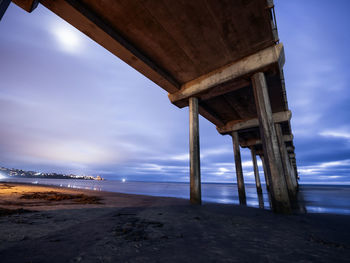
(189, 97, 202, 204)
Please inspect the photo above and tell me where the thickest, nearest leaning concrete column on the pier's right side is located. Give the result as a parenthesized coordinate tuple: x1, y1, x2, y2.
(252, 72, 291, 213)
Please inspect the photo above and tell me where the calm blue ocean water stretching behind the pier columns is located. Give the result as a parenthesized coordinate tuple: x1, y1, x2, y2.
(0, 178, 350, 215)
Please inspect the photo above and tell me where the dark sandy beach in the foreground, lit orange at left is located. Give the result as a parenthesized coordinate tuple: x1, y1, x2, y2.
(0, 183, 350, 263)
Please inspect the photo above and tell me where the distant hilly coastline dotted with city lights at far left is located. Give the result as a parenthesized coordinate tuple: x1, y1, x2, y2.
(0, 167, 105, 181)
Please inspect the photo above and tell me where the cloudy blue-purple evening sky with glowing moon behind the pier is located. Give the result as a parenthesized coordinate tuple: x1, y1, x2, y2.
(0, 0, 350, 184)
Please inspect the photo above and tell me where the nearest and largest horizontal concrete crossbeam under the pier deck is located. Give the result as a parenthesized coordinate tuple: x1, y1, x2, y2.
(169, 44, 284, 106)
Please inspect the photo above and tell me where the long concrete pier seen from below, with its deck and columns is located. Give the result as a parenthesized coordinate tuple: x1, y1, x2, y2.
(0, 0, 298, 213)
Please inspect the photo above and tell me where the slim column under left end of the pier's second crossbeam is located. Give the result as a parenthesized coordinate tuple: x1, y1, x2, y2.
(232, 132, 247, 205)
